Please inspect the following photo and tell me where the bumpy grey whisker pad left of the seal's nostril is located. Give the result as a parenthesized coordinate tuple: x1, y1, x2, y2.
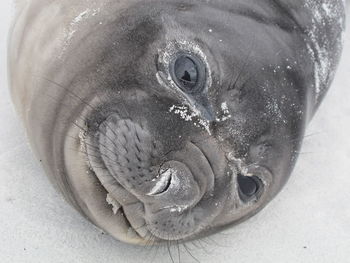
(91, 115, 161, 196)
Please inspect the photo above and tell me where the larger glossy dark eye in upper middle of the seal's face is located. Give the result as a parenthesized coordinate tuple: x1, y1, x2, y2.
(170, 54, 205, 93)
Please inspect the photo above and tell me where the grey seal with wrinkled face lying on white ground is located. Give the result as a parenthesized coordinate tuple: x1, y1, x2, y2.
(9, 0, 345, 244)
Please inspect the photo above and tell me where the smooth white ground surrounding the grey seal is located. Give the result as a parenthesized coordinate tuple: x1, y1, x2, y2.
(0, 0, 350, 263)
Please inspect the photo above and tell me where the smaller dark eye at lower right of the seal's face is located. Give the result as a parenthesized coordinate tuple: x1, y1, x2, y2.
(237, 174, 263, 203)
